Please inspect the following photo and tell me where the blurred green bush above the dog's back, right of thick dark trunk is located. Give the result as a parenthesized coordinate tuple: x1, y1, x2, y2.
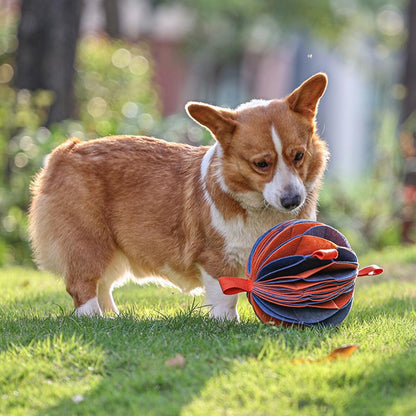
(75, 37, 159, 138)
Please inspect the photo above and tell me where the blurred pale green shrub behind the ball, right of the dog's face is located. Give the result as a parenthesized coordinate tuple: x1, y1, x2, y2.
(319, 111, 402, 253)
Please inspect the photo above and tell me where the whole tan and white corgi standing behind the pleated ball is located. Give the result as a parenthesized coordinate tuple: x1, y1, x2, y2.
(29, 73, 328, 319)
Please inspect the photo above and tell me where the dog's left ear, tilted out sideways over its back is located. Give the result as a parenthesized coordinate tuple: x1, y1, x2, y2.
(185, 101, 237, 146)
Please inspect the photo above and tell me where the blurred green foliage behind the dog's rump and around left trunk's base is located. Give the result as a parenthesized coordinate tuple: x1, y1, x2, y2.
(0, 35, 159, 265)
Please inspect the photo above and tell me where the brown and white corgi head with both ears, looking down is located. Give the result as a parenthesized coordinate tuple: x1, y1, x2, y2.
(186, 73, 328, 213)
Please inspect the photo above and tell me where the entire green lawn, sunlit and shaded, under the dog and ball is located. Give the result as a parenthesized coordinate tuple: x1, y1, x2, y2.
(0, 249, 416, 416)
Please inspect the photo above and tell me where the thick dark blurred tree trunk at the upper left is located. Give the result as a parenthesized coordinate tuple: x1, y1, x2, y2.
(16, 0, 82, 125)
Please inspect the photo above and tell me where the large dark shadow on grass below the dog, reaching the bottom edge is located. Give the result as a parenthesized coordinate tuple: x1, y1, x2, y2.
(5, 313, 273, 415)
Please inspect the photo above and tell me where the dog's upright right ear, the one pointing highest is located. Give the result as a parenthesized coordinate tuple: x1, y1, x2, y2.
(286, 72, 328, 119)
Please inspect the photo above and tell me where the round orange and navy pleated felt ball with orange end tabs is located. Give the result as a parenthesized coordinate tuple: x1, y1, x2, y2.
(219, 220, 383, 326)
